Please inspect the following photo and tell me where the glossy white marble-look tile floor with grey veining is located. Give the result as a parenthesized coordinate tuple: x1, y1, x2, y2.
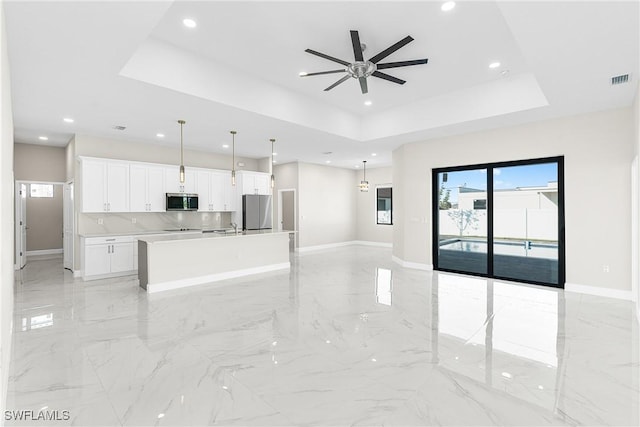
(7, 246, 640, 426)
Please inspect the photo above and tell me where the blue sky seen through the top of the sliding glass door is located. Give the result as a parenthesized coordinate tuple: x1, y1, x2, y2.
(440, 163, 558, 202)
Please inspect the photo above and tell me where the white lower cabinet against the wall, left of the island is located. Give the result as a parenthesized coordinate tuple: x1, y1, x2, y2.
(81, 236, 135, 280)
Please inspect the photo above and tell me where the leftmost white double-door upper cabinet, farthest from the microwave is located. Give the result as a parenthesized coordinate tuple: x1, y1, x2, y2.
(81, 159, 129, 213)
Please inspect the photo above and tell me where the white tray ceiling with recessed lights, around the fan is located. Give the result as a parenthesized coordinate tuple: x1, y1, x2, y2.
(4, 1, 640, 168)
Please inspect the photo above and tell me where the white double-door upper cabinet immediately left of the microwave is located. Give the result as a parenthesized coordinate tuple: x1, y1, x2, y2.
(129, 163, 165, 212)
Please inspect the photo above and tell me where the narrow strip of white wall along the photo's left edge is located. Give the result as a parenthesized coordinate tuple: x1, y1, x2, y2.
(0, 4, 14, 413)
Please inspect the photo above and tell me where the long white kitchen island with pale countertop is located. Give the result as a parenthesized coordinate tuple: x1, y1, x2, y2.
(138, 230, 291, 293)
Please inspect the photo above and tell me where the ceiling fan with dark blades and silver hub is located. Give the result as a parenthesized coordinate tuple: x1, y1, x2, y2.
(300, 30, 428, 94)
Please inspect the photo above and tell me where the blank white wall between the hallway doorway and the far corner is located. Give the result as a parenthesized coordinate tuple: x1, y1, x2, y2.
(298, 163, 356, 248)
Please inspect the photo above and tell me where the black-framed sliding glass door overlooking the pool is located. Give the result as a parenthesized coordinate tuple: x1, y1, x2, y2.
(433, 157, 564, 287)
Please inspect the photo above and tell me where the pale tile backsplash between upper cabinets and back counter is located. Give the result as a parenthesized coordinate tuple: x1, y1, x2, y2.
(77, 212, 234, 235)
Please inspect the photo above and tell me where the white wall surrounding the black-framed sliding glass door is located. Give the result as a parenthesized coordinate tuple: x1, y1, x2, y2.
(393, 108, 634, 291)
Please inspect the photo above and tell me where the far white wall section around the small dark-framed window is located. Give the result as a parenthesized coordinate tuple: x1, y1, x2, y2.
(353, 167, 396, 245)
